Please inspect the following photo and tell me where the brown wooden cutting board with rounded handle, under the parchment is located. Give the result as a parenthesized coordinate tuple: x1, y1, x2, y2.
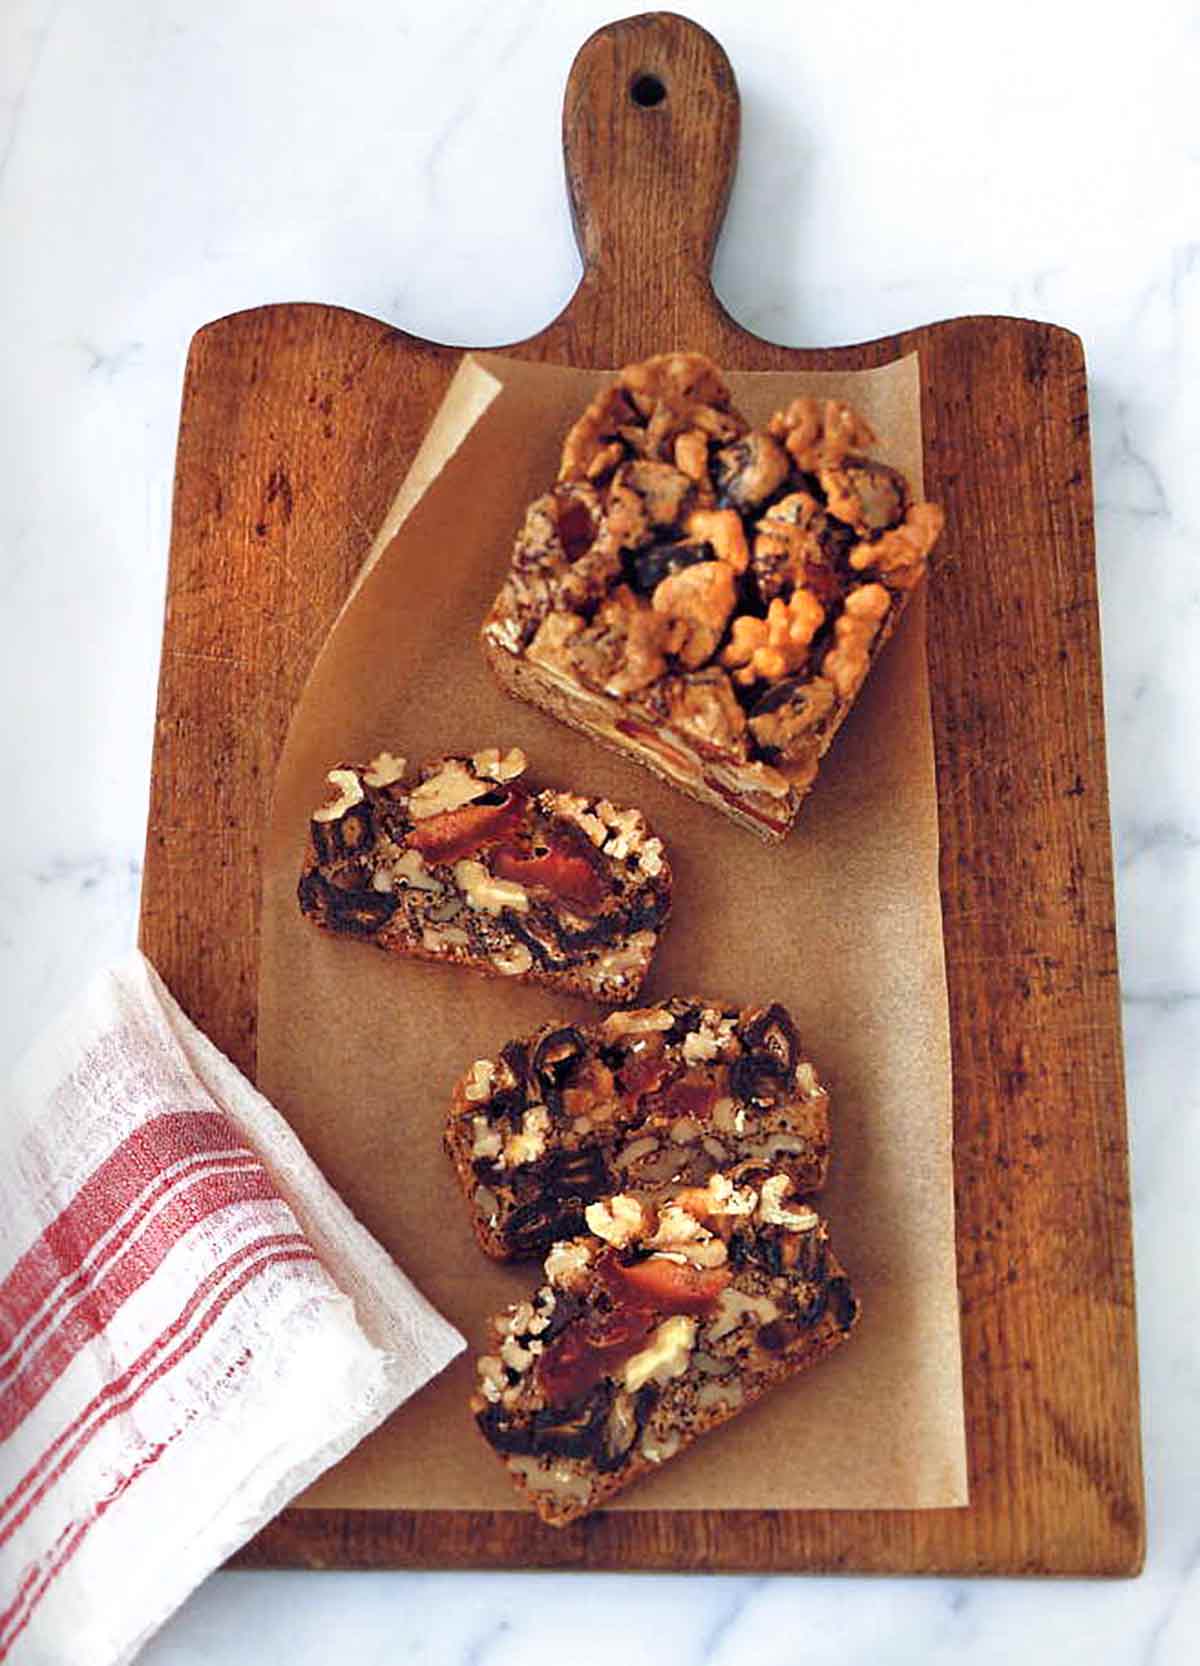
(142, 13, 1145, 1574)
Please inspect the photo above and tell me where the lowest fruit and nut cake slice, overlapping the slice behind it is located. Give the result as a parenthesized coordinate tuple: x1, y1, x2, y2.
(472, 1175, 858, 1526)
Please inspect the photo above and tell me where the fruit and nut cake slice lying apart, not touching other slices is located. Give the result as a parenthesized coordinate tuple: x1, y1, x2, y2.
(298, 746, 672, 1003)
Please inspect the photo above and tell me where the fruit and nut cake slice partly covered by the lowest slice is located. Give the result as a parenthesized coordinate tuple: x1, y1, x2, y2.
(445, 996, 830, 1259)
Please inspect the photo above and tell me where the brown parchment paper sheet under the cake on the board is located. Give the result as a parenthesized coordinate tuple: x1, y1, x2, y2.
(258, 353, 967, 1509)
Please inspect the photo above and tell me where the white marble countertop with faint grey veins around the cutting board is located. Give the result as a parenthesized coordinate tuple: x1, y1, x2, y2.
(0, 0, 1200, 1666)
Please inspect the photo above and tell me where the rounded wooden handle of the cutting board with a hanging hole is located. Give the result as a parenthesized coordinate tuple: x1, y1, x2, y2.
(563, 12, 742, 310)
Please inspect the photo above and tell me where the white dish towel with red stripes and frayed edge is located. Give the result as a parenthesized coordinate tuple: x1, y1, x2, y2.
(0, 955, 465, 1666)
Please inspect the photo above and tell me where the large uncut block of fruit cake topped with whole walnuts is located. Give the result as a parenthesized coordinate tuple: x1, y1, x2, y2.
(483, 353, 942, 840)
